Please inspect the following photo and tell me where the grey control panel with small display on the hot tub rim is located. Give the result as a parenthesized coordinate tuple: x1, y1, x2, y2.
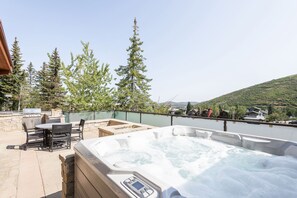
(121, 176, 157, 198)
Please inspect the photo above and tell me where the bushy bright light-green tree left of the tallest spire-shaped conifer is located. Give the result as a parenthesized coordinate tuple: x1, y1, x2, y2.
(63, 42, 113, 111)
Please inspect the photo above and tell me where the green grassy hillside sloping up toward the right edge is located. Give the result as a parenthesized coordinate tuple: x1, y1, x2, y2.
(200, 75, 297, 109)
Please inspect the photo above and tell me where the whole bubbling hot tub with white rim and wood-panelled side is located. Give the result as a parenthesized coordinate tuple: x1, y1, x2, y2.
(75, 126, 297, 198)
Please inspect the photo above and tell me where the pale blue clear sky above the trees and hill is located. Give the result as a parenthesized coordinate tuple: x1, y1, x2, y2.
(0, 0, 297, 102)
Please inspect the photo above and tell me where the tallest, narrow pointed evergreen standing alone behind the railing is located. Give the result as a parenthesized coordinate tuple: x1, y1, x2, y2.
(115, 18, 151, 111)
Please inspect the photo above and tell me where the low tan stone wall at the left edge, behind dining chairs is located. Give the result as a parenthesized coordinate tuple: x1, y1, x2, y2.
(0, 114, 23, 133)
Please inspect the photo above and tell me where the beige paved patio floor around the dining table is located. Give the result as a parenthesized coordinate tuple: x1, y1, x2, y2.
(0, 127, 98, 198)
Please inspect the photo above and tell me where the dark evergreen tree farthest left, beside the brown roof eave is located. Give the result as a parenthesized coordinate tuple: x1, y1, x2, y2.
(0, 38, 25, 110)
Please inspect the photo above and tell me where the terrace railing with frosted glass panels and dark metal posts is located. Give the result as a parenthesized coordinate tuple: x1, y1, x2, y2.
(64, 111, 297, 142)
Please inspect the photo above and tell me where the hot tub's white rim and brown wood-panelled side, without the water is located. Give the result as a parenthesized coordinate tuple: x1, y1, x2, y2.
(75, 126, 297, 197)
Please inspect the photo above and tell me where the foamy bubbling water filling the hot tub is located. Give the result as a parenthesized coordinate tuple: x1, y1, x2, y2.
(95, 136, 297, 197)
